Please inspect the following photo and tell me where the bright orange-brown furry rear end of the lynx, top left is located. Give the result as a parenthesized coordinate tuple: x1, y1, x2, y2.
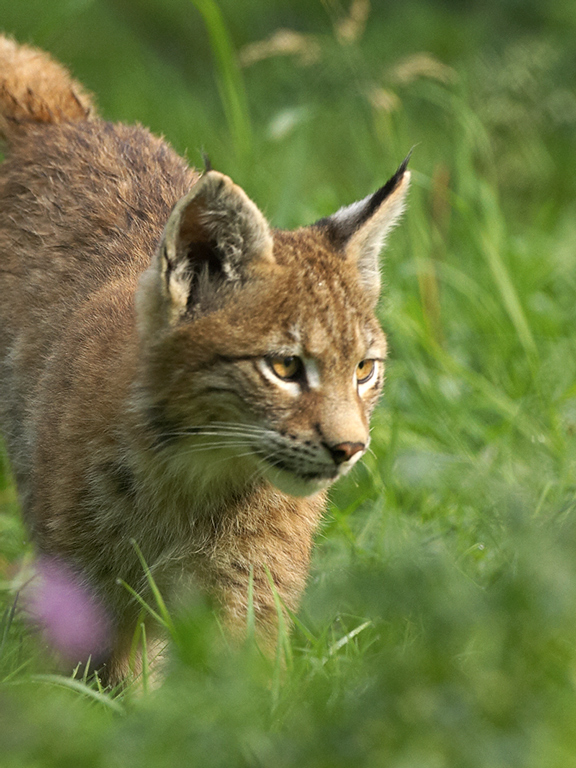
(0, 35, 94, 144)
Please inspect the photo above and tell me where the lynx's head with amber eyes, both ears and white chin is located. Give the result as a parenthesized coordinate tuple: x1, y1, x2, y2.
(137, 160, 410, 495)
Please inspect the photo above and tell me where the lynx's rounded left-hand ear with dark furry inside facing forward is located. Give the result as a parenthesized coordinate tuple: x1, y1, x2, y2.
(153, 170, 273, 315)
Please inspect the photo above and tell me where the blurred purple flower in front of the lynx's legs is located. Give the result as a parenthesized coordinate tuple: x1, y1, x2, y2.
(22, 557, 112, 664)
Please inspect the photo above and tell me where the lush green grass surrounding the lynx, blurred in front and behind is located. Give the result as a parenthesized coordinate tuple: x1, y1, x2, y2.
(0, 0, 576, 768)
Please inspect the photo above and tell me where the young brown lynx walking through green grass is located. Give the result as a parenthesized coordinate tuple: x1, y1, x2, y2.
(0, 37, 409, 685)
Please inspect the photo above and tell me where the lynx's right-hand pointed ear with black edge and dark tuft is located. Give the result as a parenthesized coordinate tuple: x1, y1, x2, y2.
(317, 155, 410, 300)
